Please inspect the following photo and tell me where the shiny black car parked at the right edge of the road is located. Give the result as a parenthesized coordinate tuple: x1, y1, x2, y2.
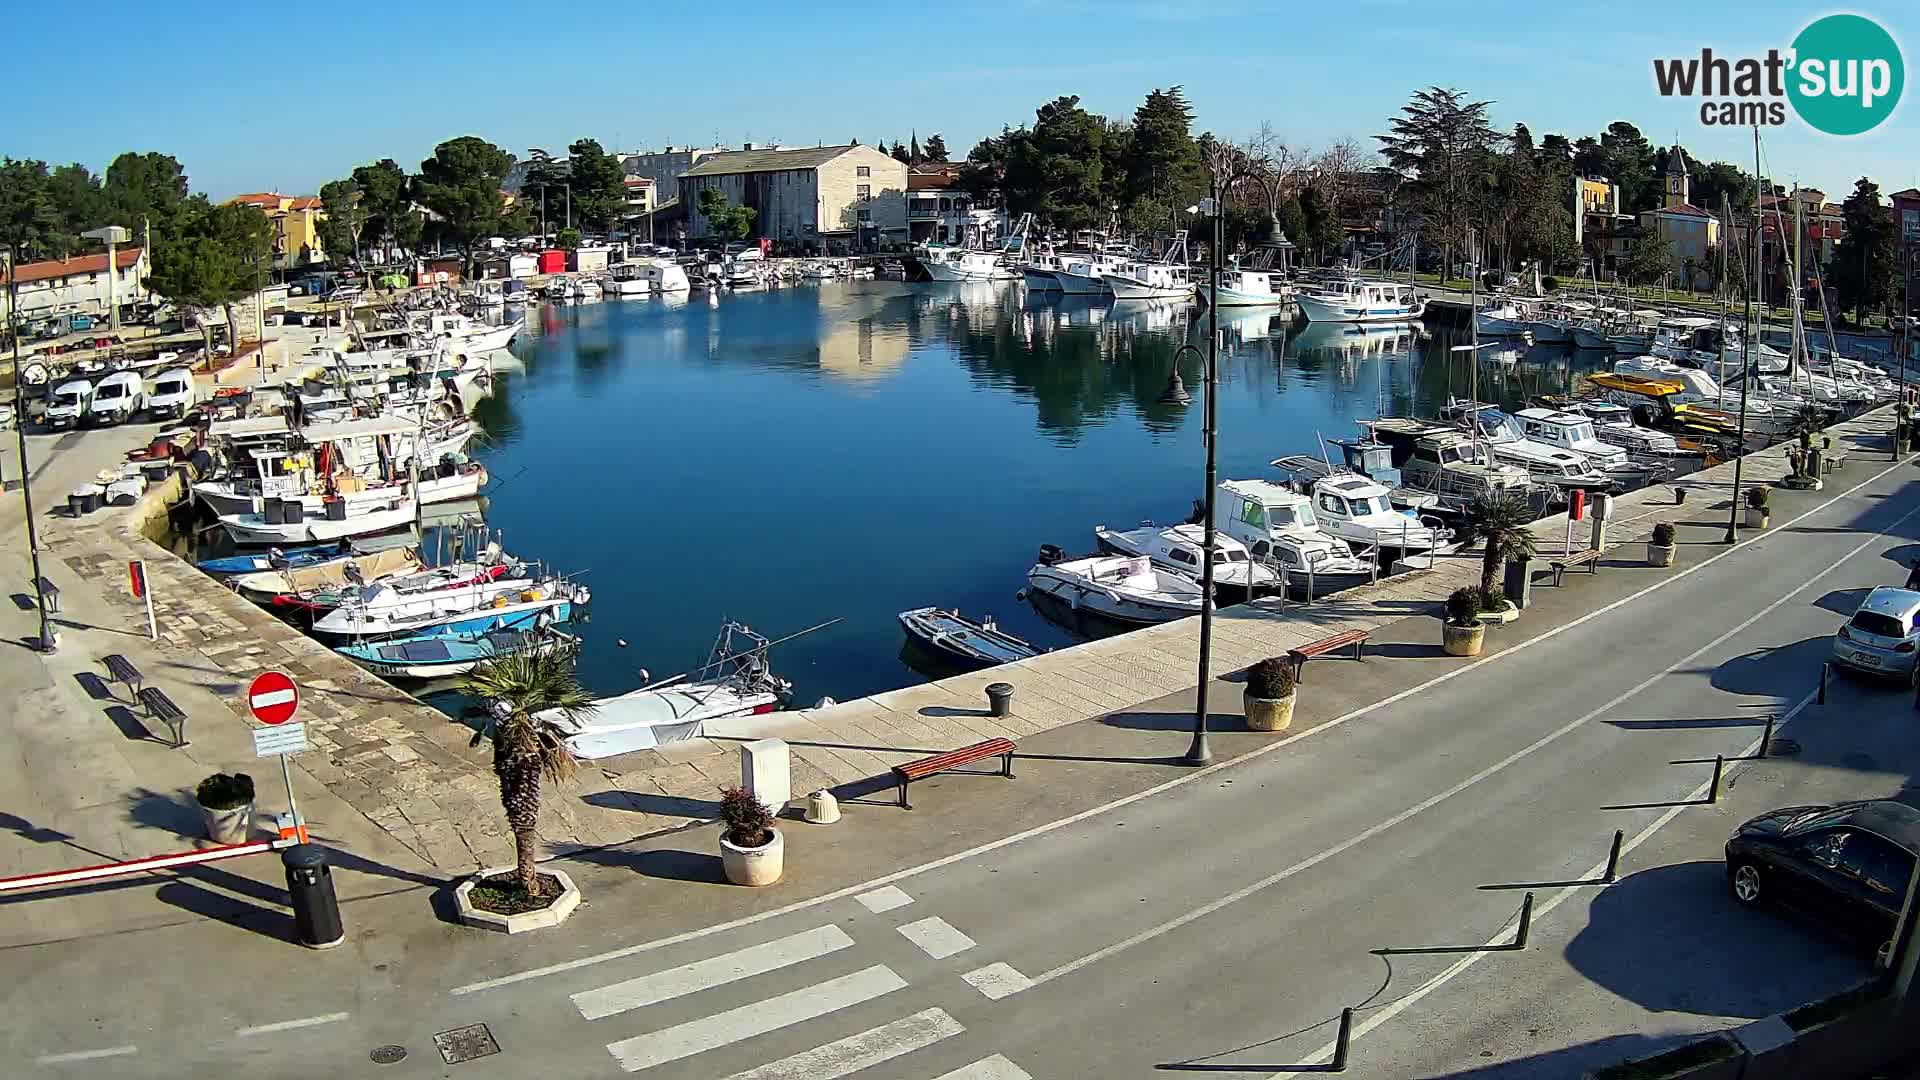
(1726, 801, 1920, 963)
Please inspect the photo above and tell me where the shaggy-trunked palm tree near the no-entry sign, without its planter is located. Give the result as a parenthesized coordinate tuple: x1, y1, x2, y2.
(461, 651, 593, 897)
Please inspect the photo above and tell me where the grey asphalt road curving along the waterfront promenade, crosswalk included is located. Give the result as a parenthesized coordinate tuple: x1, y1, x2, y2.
(8, 455, 1920, 1080)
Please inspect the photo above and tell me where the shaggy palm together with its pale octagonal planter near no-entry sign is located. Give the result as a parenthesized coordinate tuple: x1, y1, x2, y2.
(455, 651, 593, 934)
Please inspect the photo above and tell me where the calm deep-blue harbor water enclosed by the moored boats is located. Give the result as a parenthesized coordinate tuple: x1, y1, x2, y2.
(464, 282, 1607, 705)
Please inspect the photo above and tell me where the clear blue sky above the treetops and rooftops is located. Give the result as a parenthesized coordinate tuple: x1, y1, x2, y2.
(0, 0, 1920, 196)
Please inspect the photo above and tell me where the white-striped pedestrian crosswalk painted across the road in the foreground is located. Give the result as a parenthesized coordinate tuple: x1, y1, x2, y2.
(572, 890, 1033, 1080)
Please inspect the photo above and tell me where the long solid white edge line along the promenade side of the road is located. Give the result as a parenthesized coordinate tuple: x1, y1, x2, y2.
(447, 447, 1912, 995)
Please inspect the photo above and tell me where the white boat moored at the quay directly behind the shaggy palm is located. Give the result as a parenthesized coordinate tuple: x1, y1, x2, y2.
(536, 623, 793, 761)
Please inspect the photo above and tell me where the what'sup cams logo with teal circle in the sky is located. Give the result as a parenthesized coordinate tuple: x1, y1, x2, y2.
(1653, 15, 1907, 135)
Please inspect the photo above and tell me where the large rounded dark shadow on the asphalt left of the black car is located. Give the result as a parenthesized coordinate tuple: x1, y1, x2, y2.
(1567, 861, 1868, 1019)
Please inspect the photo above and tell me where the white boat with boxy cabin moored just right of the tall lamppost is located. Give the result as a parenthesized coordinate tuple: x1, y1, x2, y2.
(1213, 480, 1379, 600)
